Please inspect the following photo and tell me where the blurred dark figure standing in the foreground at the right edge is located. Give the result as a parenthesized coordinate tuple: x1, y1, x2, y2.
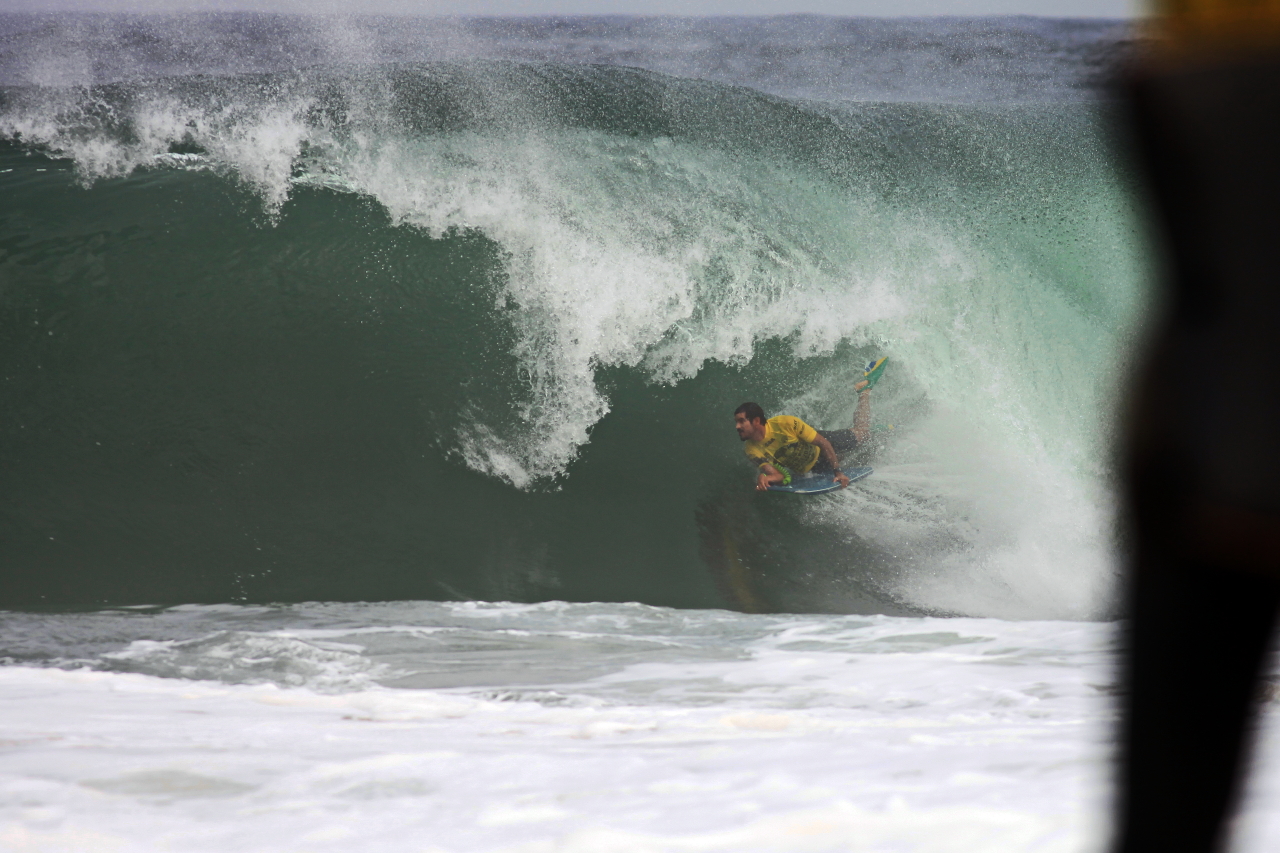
(1114, 0, 1280, 853)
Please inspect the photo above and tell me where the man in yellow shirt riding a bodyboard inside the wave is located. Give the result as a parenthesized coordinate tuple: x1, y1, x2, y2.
(733, 357, 888, 492)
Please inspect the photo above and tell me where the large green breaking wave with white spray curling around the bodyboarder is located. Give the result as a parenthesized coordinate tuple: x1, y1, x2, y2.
(0, 17, 1147, 619)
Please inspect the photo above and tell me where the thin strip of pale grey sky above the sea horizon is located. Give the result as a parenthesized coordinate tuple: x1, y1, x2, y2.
(0, 0, 1143, 18)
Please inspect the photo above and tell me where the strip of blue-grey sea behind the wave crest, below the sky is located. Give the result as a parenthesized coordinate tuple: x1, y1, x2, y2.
(0, 13, 1135, 102)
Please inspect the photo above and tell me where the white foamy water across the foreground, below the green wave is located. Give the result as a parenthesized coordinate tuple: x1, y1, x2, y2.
(0, 605, 1126, 853)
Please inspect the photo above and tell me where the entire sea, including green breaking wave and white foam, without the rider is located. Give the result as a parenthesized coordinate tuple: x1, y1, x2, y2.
(0, 14, 1280, 853)
